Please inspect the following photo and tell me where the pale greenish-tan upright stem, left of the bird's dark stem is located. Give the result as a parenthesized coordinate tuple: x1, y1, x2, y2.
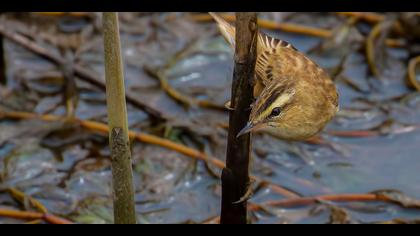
(103, 12, 136, 224)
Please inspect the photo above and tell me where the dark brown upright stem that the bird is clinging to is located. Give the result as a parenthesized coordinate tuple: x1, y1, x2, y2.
(220, 12, 258, 224)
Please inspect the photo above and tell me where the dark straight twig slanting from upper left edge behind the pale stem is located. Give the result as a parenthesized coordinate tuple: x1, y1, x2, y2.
(0, 23, 165, 120)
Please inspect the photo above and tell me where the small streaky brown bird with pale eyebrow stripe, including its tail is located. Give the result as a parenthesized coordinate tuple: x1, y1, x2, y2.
(210, 12, 338, 141)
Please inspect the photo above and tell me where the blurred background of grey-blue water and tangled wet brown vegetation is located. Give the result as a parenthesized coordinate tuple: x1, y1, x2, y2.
(0, 12, 420, 223)
